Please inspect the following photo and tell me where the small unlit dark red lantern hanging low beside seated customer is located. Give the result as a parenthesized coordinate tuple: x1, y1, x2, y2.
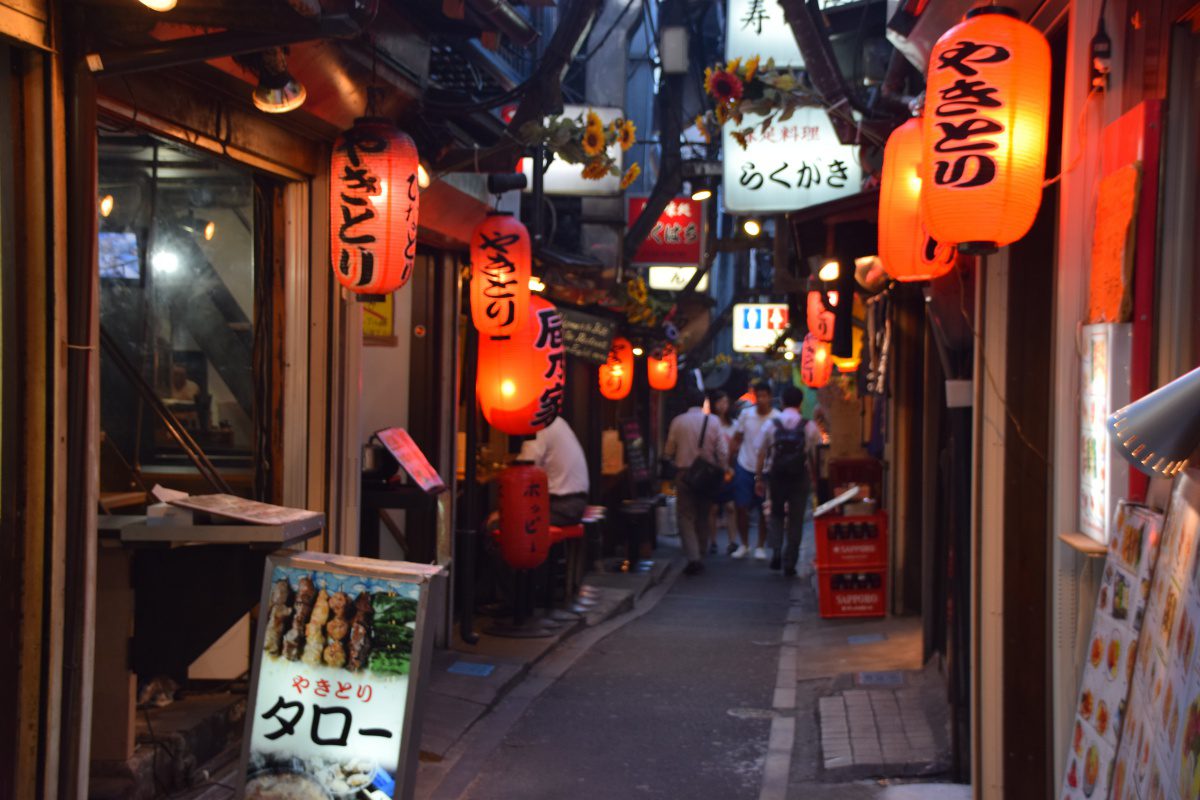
(496, 462, 551, 570)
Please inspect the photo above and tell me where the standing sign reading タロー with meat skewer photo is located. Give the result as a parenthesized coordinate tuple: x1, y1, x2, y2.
(238, 553, 440, 800)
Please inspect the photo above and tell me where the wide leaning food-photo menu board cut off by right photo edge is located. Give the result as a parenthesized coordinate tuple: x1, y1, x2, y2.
(1096, 469, 1200, 800)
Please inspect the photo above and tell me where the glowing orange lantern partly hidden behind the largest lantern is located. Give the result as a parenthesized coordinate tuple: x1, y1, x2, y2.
(880, 119, 955, 281)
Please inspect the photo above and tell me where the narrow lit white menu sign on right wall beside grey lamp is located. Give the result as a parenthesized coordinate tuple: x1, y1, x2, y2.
(1079, 324, 1132, 545)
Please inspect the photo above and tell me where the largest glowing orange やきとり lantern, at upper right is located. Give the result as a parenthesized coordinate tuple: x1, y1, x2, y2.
(920, 6, 1050, 254)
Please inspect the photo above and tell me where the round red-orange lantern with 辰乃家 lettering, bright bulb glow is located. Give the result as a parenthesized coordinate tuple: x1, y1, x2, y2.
(475, 296, 566, 435)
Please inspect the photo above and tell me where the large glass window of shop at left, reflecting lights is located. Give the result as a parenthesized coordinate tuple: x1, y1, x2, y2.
(97, 131, 258, 494)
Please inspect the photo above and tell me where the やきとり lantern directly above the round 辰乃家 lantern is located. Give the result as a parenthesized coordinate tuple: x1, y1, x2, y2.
(470, 211, 530, 336)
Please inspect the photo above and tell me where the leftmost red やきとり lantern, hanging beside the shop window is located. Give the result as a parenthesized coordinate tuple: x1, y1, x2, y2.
(329, 118, 420, 295)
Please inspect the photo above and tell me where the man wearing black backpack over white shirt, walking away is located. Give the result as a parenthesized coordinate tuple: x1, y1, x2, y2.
(755, 386, 821, 577)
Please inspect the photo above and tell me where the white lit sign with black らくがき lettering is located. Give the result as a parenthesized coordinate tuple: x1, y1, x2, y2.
(721, 107, 863, 213)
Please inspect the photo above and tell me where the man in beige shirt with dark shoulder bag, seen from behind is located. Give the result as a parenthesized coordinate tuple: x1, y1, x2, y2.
(662, 387, 728, 575)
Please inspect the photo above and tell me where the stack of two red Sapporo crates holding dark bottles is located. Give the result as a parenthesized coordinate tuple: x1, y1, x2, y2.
(815, 512, 888, 619)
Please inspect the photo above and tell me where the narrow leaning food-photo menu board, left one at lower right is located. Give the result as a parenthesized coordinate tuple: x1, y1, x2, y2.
(1062, 501, 1163, 800)
